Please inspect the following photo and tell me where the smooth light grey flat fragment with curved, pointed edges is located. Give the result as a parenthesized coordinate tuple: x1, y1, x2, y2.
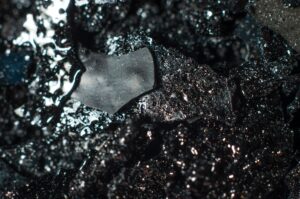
(72, 48, 154, 114)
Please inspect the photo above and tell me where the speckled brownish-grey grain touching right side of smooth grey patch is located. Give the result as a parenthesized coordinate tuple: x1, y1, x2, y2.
(132, 47, 234, 122)
